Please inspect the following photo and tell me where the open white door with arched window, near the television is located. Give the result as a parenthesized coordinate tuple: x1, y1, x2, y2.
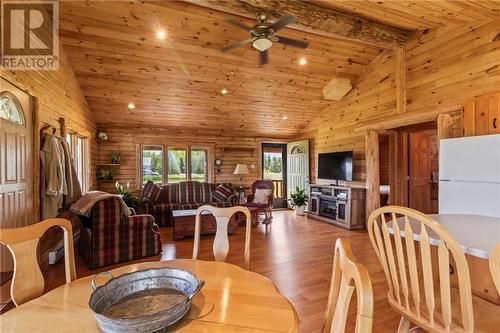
(286, 140, 309, 205)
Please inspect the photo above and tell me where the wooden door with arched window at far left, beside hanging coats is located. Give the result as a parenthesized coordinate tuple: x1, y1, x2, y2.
(0, 79, 34, 272)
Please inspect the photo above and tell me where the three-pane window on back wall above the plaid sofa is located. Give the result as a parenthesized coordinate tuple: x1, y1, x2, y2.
(141, 145, 210, 184)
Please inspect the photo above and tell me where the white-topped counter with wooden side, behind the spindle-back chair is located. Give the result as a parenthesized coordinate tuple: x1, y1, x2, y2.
(387, 214, 500, 305)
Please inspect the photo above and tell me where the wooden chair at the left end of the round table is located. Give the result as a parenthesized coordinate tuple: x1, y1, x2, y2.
(0, 218, 76, 306)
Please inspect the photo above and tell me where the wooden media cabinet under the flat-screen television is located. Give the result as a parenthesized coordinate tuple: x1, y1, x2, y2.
(307, 184, 365, 229)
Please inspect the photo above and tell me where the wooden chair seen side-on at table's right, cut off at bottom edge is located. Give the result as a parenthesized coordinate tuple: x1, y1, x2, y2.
(323, 238, 373, 333)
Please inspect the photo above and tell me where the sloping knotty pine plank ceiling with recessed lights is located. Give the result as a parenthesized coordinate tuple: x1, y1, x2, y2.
(60, 1, 381, 137)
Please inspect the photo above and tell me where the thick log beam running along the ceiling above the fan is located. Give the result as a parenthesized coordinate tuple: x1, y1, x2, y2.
(185, 0, 411, 49)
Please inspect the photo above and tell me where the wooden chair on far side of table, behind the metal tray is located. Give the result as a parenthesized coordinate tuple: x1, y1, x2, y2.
(193, 205, 252, 269)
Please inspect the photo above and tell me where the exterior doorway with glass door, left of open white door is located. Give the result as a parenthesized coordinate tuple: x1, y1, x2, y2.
(262, 143, 287, 208)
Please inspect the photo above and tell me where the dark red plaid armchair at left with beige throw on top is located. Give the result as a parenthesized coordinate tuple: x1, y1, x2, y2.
(78, 198, 162, 269)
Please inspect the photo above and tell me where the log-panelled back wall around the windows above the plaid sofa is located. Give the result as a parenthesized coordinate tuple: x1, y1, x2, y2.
(95, 127, 284, 192)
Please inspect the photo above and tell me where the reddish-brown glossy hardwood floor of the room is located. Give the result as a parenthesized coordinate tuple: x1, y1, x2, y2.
(39, 211, 400, 333)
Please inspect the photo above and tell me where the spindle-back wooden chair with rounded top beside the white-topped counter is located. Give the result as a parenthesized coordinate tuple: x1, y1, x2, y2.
(368, 206, 500, 333)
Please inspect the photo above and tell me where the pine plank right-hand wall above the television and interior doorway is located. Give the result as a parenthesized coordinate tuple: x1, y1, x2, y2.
(300, 21, 500, 181)
